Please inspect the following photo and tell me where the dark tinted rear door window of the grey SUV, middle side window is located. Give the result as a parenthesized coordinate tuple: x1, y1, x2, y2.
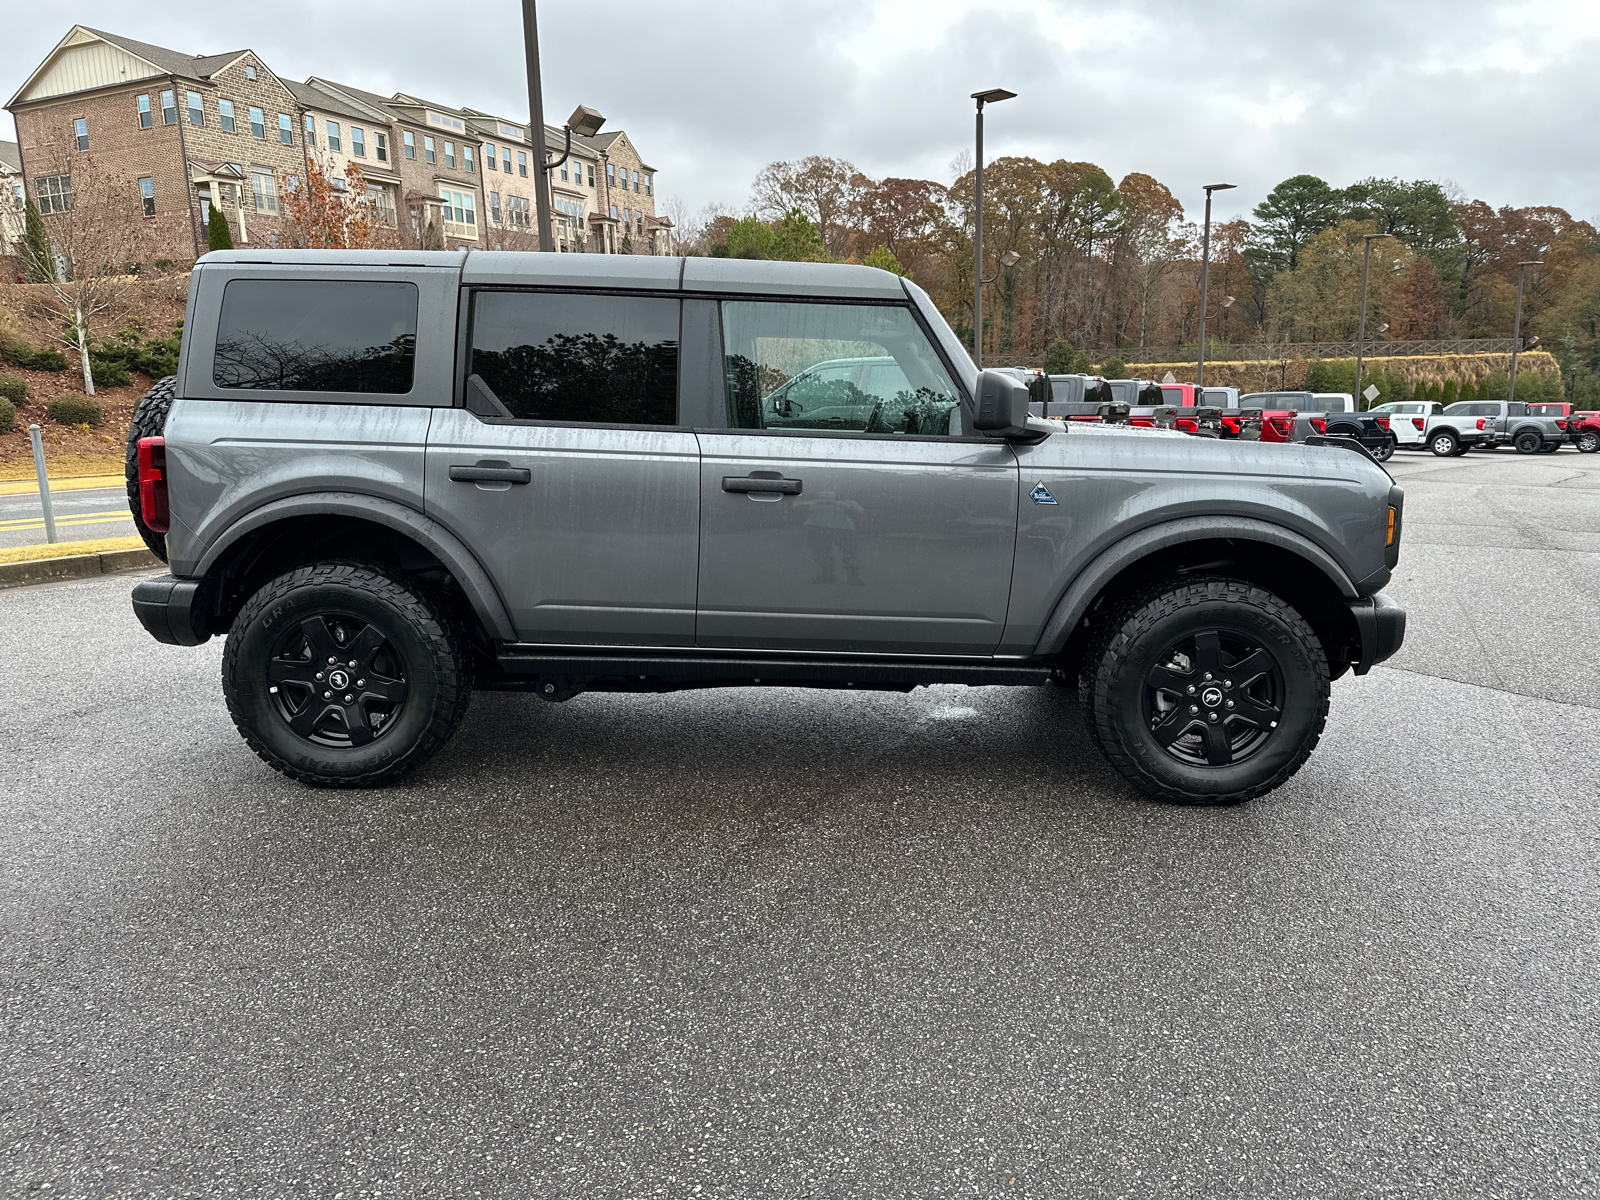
(467, 291, 678, 426)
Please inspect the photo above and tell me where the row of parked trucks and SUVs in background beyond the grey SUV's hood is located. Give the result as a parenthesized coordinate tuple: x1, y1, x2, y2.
(1016, 370, 1600, 462)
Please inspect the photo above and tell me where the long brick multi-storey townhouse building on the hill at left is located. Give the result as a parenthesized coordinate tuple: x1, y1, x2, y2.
(0, 26, 672, 261)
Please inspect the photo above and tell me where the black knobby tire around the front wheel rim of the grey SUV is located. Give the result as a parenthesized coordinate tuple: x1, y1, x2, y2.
(1078, 576, 1331, 806)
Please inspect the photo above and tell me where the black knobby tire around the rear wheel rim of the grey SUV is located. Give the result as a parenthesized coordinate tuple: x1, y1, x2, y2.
(222, 562, 472, 787)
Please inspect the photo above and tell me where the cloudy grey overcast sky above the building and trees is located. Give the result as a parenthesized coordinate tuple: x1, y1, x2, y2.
(0, 0, 1600, 221)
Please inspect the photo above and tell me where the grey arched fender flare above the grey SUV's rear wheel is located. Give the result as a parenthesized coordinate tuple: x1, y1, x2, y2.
(194, 491, 517, 642)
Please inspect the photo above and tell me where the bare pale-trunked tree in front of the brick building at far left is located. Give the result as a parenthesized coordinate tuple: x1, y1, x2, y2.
(16, 149, 155, 395)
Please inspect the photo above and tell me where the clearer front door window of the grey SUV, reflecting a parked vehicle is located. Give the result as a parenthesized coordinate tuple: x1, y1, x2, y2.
(722, 301, 962, 437)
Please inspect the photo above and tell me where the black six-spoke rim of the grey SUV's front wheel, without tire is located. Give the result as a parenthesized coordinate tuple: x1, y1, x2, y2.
(1144, 629, 1285, 766)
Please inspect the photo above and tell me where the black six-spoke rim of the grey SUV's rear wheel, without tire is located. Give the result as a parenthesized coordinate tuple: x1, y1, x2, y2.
(266, 613, 406, 749)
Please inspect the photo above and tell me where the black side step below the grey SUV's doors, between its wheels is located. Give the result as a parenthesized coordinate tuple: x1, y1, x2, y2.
(491, 648, 1050, 690)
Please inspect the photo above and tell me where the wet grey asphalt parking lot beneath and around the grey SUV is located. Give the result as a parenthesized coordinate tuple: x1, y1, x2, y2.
(0, 451, 1600, 1198)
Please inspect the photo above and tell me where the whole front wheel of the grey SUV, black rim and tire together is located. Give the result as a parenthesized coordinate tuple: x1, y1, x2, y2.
(1078, 578, 1330, 805)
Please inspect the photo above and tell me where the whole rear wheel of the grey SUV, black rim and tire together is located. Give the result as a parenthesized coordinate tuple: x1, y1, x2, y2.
(222, 563, 472, 787)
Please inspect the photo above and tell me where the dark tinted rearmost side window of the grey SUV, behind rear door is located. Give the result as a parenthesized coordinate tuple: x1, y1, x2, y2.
(211, 278, 418, 395)
